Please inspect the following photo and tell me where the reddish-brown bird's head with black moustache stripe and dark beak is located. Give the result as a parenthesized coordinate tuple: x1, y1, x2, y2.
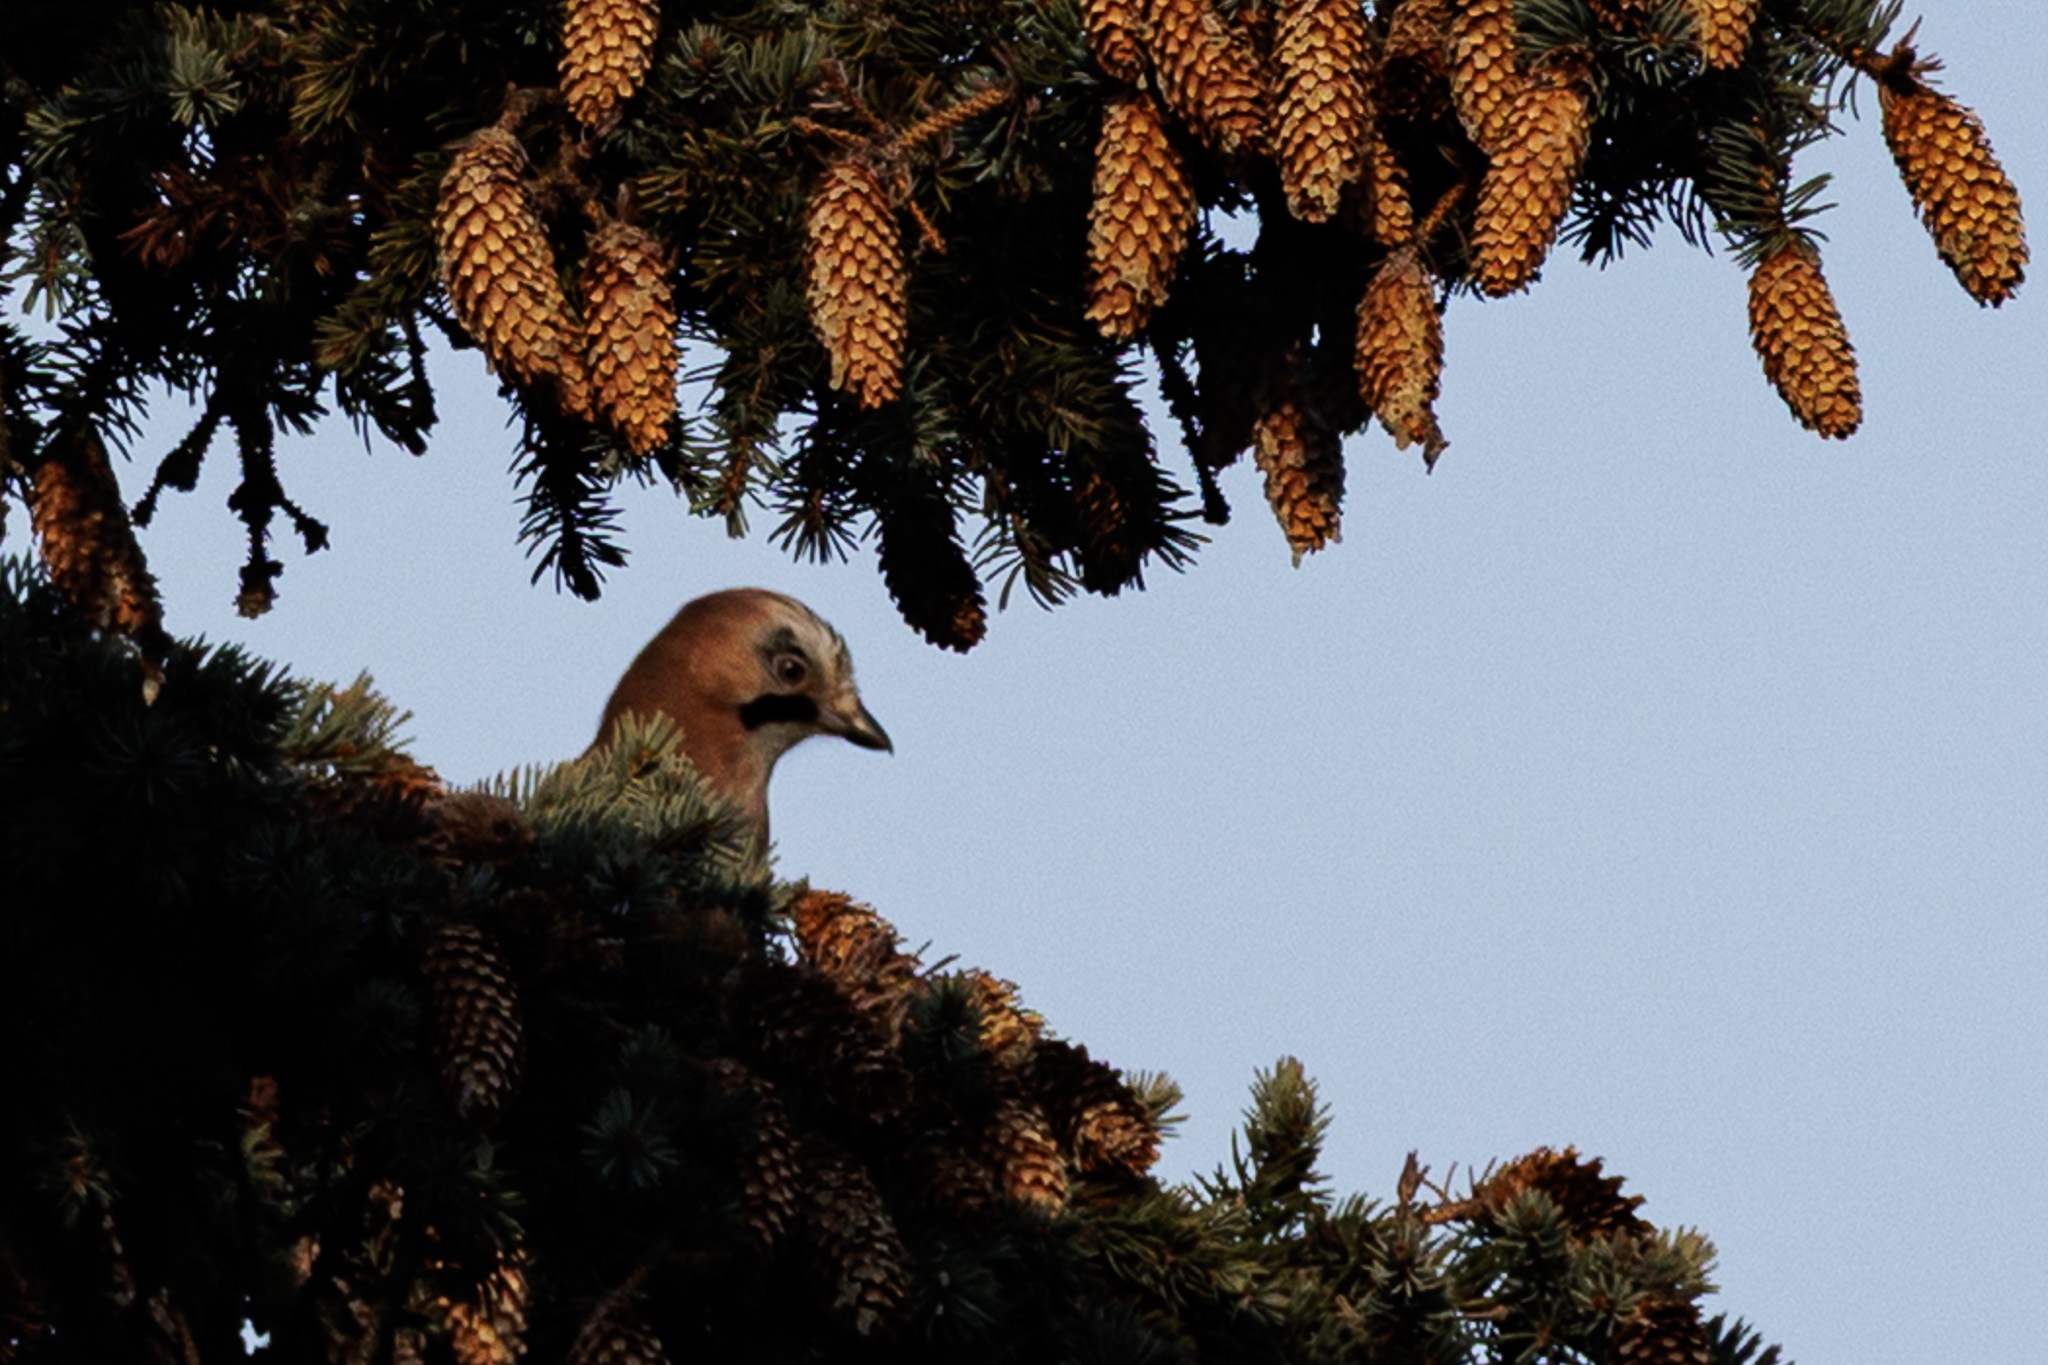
(598, 587, 895, 843)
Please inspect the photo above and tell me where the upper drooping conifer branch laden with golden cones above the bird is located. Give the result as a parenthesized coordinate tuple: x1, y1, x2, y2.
(0, 0, 2028, 649)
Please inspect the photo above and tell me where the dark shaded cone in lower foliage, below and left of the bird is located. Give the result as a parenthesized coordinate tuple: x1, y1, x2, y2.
(422, 921, 522, 1119)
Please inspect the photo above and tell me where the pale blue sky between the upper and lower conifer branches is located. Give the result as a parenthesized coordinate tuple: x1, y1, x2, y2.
(10, 0, 2048, 1365)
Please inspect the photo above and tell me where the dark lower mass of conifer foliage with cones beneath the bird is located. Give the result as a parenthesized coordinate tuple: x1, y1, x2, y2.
(0, 561, 1802, 1365)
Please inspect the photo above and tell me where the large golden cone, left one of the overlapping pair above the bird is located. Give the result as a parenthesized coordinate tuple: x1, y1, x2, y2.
(434, 127, 588, 417)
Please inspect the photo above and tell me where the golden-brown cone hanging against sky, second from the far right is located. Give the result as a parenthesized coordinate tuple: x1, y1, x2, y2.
(1749, 241, 1864, 438)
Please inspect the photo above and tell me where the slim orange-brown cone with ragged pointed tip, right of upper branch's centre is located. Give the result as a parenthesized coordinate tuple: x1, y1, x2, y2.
(1358, 248, 1448, 467)
